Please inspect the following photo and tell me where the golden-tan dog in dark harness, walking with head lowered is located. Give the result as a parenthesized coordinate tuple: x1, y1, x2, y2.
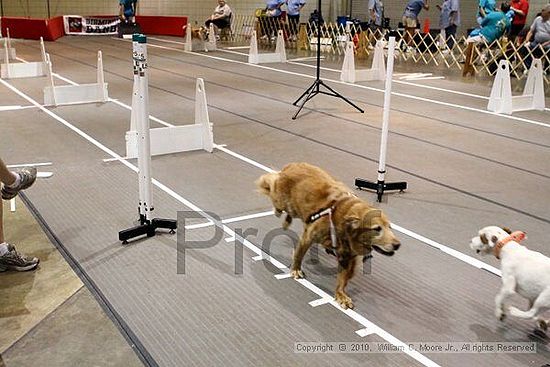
(256, 163, 401, 309)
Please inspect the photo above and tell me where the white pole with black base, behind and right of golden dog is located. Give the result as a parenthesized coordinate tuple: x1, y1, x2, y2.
(355, 37, 407, 202)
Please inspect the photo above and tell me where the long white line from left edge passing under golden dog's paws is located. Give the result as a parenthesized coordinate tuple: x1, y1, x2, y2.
(0, 79, 439, 367)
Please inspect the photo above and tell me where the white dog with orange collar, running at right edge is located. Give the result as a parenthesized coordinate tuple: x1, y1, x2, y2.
(470, 226, 550, 331)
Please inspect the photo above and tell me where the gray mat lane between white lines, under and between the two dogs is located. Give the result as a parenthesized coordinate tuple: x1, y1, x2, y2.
(212, 217, 550, 366)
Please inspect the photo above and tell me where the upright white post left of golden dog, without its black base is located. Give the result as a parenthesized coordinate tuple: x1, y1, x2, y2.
(132, 34, 154, 221)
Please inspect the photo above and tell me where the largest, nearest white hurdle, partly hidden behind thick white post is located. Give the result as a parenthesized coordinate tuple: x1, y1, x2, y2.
(126, 78, 214, 158)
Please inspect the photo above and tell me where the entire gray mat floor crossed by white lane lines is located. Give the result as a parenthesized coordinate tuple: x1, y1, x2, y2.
(0, 37, 550, 367)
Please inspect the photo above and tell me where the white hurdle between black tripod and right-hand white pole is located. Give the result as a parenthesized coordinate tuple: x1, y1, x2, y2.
(340, 40, 386, 83)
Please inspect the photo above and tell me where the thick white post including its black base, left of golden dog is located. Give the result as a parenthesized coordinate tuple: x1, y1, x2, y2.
(118, 34, 177, 244)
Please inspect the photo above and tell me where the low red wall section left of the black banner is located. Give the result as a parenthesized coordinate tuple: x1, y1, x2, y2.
(2, 16, 65, 41)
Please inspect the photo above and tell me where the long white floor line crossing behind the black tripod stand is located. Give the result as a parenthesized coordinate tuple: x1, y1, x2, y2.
(138, 39, 550, 128)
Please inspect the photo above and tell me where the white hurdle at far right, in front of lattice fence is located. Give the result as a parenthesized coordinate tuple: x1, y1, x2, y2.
(487, 59, 545, 115)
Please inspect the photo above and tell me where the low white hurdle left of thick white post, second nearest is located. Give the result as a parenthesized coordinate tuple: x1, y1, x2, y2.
(44, 51, 109, 106)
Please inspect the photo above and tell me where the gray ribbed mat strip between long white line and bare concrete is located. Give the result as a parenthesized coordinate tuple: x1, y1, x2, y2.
(1, 110, 422, 366)
